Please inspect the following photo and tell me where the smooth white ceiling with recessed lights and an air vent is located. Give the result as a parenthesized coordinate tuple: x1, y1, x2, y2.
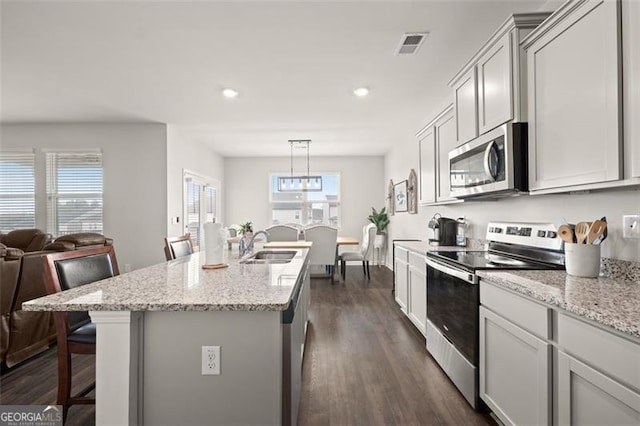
(0, 0, 544, 156)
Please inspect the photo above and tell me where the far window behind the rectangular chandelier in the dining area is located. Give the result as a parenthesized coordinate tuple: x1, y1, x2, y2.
(269, 173, 340, 227)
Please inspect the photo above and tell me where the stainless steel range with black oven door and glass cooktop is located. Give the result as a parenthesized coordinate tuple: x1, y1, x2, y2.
(427, 222, 564, 408)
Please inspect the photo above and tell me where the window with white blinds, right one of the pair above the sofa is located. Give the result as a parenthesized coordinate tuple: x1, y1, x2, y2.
(46, 152, 103, 236)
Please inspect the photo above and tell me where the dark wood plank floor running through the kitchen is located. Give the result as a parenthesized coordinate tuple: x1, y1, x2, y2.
(0, 265, 495, 425)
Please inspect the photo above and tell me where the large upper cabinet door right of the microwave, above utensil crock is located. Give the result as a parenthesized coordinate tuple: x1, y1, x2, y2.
(527, 0, 621, 191)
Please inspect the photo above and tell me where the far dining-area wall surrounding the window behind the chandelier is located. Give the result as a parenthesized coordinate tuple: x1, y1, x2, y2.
(224, 156, 385, 238)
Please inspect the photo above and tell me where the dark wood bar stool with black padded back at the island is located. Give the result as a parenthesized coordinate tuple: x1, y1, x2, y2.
(43, 246, 120, 422)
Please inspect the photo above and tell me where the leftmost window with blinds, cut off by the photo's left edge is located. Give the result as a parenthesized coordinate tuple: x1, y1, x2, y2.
(0, 151, 36, 232)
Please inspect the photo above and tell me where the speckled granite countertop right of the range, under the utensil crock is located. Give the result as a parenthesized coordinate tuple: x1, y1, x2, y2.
(478, 271, 640, 337)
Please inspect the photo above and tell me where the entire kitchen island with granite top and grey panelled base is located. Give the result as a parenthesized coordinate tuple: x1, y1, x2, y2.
(23, 249, 310, 425)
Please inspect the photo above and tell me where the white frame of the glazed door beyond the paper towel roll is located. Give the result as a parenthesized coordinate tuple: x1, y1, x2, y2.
(182, 169, 222, 247)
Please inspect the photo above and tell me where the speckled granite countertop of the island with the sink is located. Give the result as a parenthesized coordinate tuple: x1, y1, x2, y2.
(22, 249, 309, 311)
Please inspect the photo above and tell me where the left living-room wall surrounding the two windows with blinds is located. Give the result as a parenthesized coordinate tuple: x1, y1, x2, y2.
(0, 124, 167, 270)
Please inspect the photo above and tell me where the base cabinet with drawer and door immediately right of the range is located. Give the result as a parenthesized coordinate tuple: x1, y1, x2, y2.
(480, 281, 551, 425)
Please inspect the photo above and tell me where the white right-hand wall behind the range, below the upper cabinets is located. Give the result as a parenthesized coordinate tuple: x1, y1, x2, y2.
(385, 130, 640, 262)
